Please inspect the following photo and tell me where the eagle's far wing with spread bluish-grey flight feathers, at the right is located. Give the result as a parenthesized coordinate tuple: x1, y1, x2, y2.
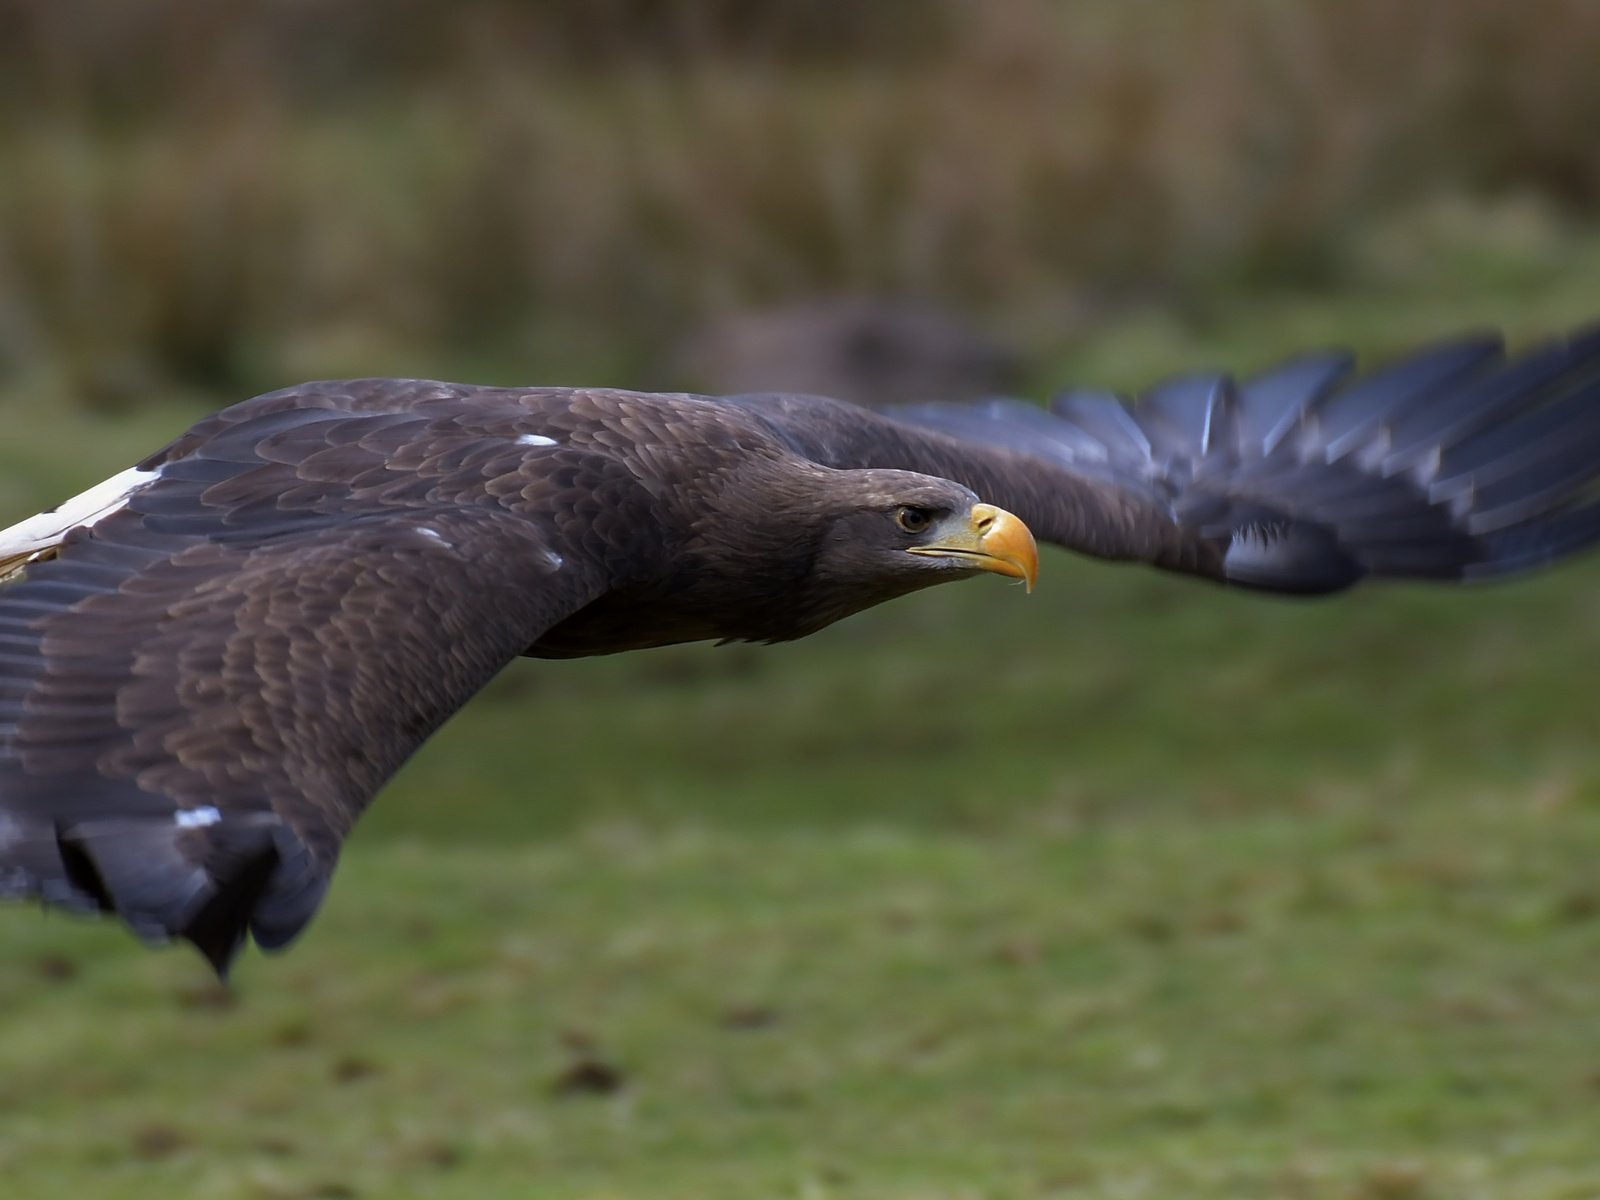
(731, 331, 1600, 592)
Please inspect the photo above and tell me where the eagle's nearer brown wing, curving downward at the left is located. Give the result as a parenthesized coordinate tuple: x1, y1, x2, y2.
(0, 397, 605, 970)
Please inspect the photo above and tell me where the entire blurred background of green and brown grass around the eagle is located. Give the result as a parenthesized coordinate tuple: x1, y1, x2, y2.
(0, 0, 1600, 1200)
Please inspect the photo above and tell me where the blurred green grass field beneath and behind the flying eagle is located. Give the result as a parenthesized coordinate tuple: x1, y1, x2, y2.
(0, 275, 1600, 1200)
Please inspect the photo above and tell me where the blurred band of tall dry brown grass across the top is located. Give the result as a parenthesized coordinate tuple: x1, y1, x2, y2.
(0, 0, 1600, 400)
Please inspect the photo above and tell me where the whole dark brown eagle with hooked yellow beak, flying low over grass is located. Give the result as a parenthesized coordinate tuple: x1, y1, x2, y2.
(0, 328, 1600, 974)
